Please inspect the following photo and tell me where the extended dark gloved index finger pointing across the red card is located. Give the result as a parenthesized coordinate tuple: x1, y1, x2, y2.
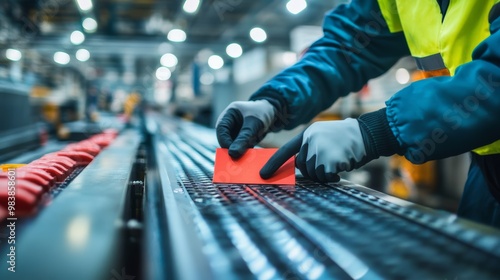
(260, 133, 303, 179)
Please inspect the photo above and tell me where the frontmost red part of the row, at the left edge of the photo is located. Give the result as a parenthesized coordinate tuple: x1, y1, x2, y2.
(0, 185, 37, 216)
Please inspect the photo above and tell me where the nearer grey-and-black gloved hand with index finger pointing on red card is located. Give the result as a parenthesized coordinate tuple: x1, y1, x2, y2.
(260, 119, 371, 182)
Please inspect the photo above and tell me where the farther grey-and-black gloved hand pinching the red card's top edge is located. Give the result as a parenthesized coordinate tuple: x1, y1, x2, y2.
(216, 100, 276, 158)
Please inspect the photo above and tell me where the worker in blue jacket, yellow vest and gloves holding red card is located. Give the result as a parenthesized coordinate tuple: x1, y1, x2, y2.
(216, 0, 500, 227)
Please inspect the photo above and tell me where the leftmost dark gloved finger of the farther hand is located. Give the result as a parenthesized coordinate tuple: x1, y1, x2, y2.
(216, 108, 243, 148)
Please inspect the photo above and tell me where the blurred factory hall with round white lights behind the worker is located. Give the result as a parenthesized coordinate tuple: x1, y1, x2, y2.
(0, 0, 468, 210)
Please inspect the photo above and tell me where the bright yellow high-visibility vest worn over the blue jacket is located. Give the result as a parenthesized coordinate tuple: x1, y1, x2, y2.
(378, 0, 500, 155)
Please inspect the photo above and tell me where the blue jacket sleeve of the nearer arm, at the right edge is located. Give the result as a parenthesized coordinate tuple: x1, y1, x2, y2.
(386, 16, 500, 163)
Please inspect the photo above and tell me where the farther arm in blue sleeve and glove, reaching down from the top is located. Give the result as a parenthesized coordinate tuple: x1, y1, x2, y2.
(216, 0, 409, 158)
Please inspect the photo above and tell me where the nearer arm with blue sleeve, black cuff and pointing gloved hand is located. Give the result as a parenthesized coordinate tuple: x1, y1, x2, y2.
(260, 4, 500, 181)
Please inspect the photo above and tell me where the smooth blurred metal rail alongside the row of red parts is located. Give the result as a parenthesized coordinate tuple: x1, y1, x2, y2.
(0, 130, 144, 280)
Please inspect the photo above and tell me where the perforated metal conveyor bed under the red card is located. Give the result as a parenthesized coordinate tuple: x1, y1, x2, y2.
(146, 116, 500, 279)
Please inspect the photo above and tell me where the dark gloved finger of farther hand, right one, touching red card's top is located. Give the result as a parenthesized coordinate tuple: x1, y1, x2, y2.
(229, 117, 266, 158)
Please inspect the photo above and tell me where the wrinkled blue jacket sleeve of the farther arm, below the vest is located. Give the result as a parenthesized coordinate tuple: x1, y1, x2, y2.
(250, 0, 409, 129)
